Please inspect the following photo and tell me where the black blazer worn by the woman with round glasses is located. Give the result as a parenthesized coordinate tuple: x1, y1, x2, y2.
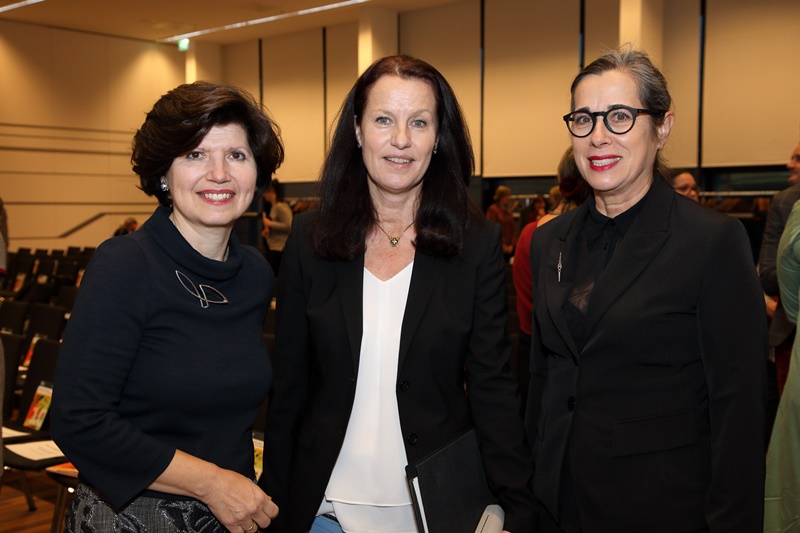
(526, 179, 767, 533)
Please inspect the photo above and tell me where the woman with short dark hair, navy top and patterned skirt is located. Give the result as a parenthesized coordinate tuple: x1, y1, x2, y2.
(51, 82, 283, 533)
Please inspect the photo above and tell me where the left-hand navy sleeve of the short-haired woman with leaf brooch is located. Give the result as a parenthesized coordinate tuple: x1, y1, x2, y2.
(51, 238, 175, 509)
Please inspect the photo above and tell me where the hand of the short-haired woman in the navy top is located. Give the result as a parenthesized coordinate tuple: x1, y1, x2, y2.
(203, 470, 278, 533)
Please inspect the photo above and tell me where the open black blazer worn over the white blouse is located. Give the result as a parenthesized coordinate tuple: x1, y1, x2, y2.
(259, 214, 534, 533)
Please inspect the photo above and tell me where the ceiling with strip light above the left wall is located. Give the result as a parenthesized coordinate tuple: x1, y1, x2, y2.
(0, 0, 456, 44)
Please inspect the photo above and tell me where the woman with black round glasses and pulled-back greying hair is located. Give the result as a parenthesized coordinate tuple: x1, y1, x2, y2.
(526, 49, 767, 533)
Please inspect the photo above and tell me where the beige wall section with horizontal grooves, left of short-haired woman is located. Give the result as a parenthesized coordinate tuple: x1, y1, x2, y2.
(0, 22, 183, 250)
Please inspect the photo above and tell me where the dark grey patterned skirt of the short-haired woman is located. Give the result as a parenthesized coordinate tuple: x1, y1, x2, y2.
(64, 483, 227, 533)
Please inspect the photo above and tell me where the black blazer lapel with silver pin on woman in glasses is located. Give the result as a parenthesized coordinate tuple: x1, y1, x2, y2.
(545, 204, 587, 358)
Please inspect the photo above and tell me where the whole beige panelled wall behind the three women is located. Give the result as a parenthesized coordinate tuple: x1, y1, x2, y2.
(0, 0, 800, 250)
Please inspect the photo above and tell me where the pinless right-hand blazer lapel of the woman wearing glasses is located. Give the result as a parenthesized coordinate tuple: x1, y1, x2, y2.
(586, 176, 674, 339)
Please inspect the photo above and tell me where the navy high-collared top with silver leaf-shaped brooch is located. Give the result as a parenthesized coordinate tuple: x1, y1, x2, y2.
(51, 206, 273, 509)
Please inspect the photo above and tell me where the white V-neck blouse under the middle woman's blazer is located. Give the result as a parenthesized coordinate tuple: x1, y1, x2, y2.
(319, 262, 418, 533)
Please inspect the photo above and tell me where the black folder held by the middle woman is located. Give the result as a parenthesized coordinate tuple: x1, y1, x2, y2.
(406, 429, 497, 533)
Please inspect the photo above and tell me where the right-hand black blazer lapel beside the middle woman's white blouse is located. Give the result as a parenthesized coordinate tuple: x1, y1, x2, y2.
(397, 252, 446, 369)
